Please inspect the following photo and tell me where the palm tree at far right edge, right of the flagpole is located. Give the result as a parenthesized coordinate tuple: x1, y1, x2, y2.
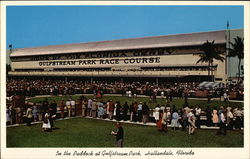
(227, 36, 244, 82)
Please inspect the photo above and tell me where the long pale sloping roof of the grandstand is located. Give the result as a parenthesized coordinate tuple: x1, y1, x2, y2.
(10, 30, 226, 57)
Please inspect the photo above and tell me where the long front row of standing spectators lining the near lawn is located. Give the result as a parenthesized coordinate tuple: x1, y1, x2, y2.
(6, 92, 244, 135)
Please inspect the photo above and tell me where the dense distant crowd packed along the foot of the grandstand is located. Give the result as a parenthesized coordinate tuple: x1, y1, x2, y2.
(6, 79, 244, 100)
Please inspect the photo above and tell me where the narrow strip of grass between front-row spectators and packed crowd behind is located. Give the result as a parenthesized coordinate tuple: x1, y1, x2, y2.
(29, 96, 243, 110)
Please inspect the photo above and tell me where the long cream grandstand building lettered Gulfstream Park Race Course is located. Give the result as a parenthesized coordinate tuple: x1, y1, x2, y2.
(9, 29, 243, 83)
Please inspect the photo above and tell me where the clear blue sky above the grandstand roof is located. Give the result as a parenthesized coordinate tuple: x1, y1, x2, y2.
(7, 6, 244, 48)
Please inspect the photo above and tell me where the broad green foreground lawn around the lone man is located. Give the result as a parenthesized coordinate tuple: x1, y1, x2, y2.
(7, 118, 243, 147)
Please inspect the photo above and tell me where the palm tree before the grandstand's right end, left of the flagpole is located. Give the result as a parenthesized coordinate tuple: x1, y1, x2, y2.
(196, 40, 225, 81)
